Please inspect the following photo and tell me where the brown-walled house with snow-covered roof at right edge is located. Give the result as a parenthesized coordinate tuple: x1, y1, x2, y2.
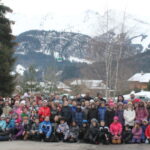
(128, 72, 150, 89)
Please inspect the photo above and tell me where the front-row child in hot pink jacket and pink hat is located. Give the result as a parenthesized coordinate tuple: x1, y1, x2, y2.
(110, 116, 122, 144)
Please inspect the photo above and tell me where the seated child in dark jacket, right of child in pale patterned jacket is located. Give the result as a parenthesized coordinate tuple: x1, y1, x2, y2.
(68, 121, 79, 143)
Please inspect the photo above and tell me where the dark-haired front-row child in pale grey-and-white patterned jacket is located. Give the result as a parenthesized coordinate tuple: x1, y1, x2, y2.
(56, 118, 69, 142)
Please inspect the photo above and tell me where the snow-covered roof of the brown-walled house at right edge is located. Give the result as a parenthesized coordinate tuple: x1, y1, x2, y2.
(128, 73, 150, 83)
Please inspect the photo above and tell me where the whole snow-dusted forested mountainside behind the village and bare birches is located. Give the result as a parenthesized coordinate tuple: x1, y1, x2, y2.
(15, 30, 149, 80)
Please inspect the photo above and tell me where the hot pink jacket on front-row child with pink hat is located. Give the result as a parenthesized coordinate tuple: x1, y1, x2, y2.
(110, 122, 122, 135)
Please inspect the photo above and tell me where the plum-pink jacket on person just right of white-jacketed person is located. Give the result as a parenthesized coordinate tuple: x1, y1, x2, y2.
(136, 107, 148, 121)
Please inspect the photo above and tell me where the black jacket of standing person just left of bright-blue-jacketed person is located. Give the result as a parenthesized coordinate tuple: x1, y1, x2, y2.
(87, 108, 98, 122)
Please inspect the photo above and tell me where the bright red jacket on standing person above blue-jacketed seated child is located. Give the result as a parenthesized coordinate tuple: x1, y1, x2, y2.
(38, 107, 51, 121)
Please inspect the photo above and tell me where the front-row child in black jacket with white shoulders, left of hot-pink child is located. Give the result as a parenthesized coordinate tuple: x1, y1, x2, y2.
(99, 121, 110, 144)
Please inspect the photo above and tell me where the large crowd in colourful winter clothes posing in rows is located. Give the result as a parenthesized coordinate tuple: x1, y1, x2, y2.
(0, 93, 150, 144)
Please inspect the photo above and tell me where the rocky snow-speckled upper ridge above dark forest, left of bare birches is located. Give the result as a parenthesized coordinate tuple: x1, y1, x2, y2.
(16, 30, 91, 59)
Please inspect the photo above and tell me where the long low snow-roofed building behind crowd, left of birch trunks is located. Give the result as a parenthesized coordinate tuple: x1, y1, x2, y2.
(70, 79, 106, 90)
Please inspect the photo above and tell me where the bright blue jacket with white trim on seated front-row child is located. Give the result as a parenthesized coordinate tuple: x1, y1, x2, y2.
(39, 121, 52, 138)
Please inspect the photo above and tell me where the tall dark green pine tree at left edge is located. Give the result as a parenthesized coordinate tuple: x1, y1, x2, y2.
(0, 2, 16, 96)
